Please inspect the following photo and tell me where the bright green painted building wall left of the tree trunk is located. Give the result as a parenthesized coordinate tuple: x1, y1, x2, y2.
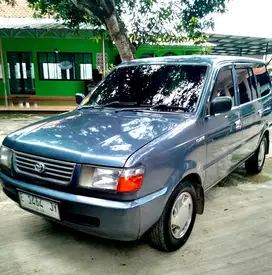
(0, 38, 111, 96)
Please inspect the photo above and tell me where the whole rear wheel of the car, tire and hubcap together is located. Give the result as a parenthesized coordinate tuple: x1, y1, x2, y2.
(245, 135, 268, 174)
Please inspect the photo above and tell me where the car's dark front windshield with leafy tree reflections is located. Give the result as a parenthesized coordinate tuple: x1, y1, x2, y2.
(81, 64, 207, 112)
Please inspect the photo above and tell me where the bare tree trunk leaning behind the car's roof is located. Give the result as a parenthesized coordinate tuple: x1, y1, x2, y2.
(105, 14, 136, 61)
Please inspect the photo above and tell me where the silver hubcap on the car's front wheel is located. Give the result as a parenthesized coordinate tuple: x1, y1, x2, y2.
(171, 192, 193, 239)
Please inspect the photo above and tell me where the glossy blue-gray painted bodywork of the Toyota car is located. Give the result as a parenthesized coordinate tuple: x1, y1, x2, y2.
(0, 56, 272, 240)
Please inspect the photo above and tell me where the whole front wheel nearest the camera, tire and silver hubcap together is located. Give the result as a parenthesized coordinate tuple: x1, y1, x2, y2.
(149, 182, 196, 252)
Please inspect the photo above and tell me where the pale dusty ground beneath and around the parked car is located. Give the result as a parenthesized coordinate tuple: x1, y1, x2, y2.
(0, 115, 272, 275)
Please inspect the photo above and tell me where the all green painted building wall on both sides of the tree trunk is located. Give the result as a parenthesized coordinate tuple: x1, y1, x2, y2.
(0, 36, 207, 99)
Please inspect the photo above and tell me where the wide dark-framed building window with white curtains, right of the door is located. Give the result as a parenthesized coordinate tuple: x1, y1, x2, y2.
(38, 53, 93, 80)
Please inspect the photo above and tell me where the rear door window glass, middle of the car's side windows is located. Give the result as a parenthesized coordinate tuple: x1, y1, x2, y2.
(236, 68, 252, 104)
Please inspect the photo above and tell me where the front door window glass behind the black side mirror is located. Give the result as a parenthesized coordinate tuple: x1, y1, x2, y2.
(210, 67, 234, 106)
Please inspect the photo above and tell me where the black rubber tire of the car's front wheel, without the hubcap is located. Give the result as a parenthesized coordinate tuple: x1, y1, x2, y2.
(148, 181, 196, 252)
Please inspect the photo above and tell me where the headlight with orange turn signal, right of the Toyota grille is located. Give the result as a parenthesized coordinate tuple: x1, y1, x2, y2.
(79, 165, 144, 192)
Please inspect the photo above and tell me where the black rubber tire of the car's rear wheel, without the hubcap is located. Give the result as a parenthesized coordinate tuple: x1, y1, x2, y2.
(245, 135, 268, 175)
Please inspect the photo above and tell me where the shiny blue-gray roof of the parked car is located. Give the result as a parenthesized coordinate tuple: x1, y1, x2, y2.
(120, 55, 265, 66)
